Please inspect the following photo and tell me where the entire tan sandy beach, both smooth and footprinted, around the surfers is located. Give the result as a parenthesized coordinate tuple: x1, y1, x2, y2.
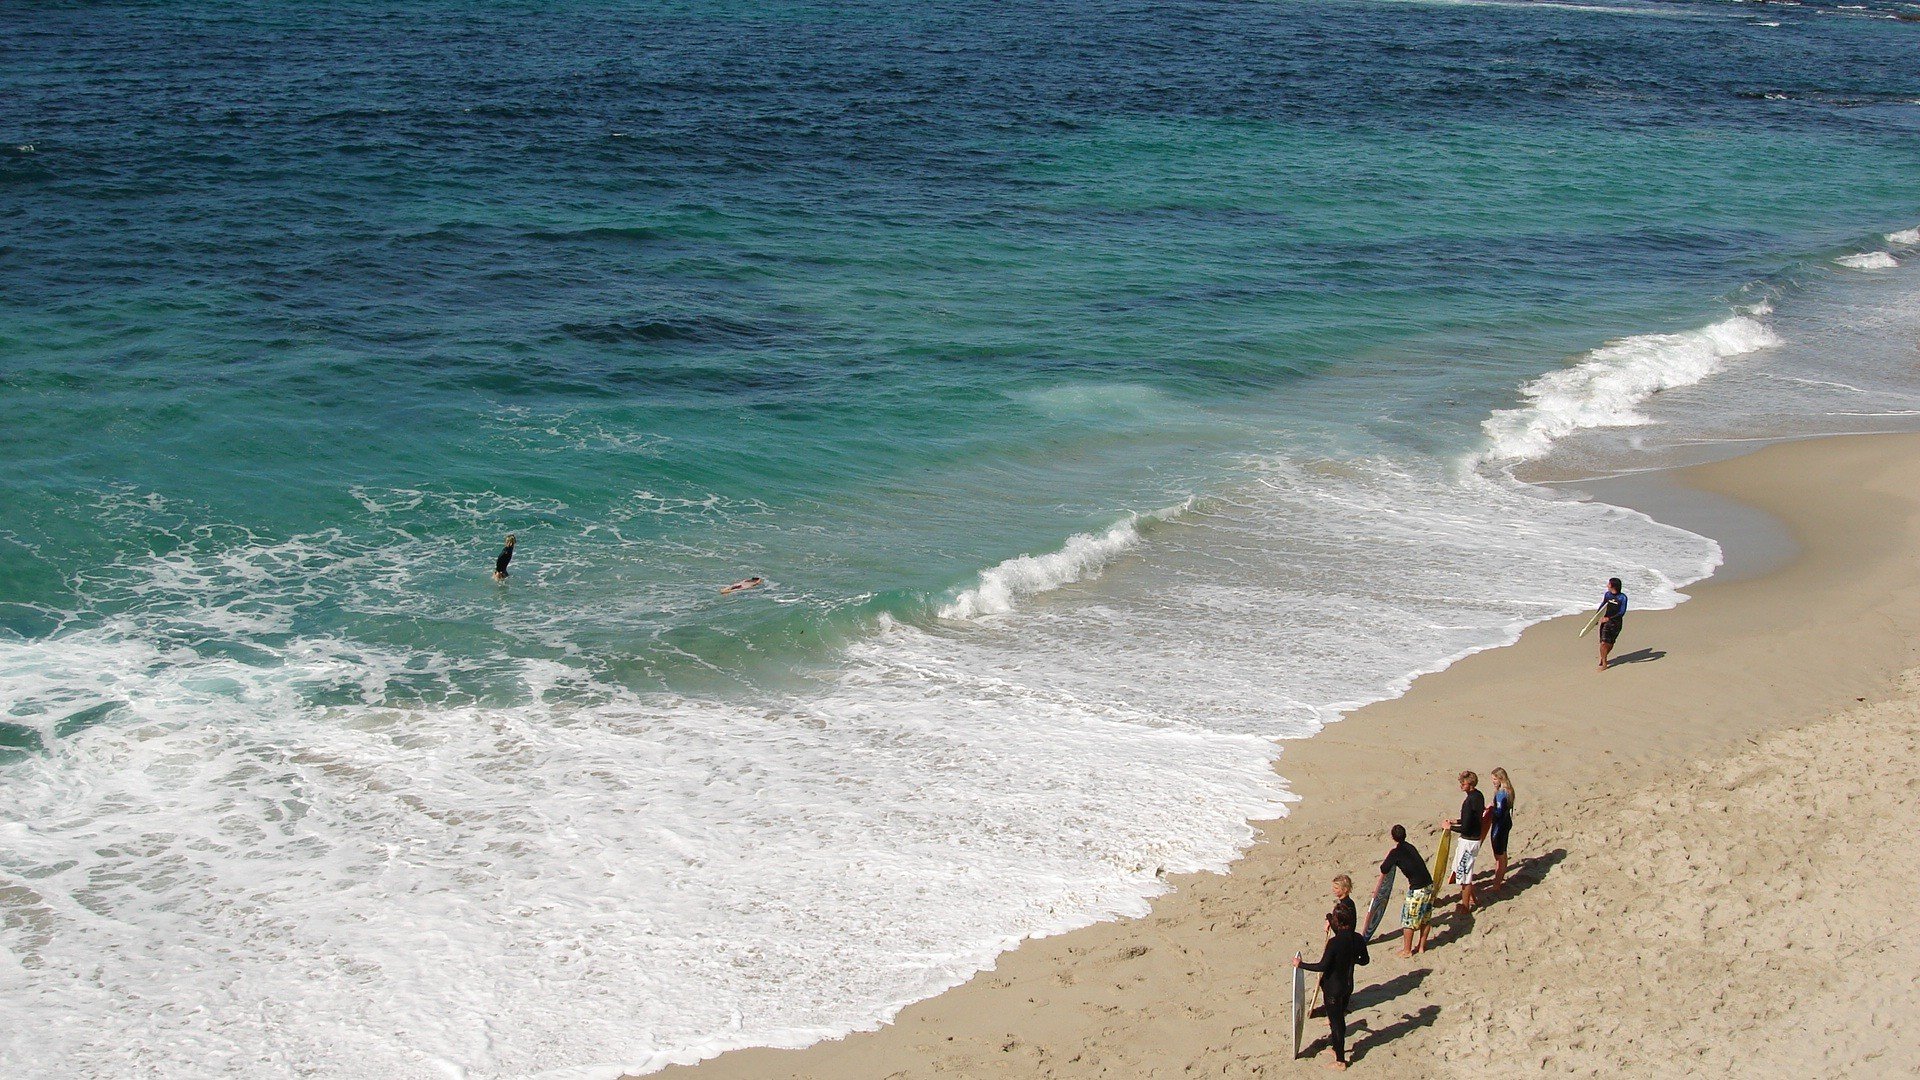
(655, 434, 1920, 1080)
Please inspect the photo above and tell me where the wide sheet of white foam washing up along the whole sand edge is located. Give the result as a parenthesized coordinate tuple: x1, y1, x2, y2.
(0, 445, 1716, 1080)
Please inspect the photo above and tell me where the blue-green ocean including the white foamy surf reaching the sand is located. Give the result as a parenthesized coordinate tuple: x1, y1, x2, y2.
(0, 0, 1920, 1080)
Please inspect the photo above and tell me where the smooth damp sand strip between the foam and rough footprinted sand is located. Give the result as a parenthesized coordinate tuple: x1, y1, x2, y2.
(647, 434, 1920, 1080)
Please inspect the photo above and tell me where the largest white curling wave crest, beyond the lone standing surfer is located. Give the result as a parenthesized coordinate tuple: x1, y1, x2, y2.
(1482, 315, 1780, 459)
